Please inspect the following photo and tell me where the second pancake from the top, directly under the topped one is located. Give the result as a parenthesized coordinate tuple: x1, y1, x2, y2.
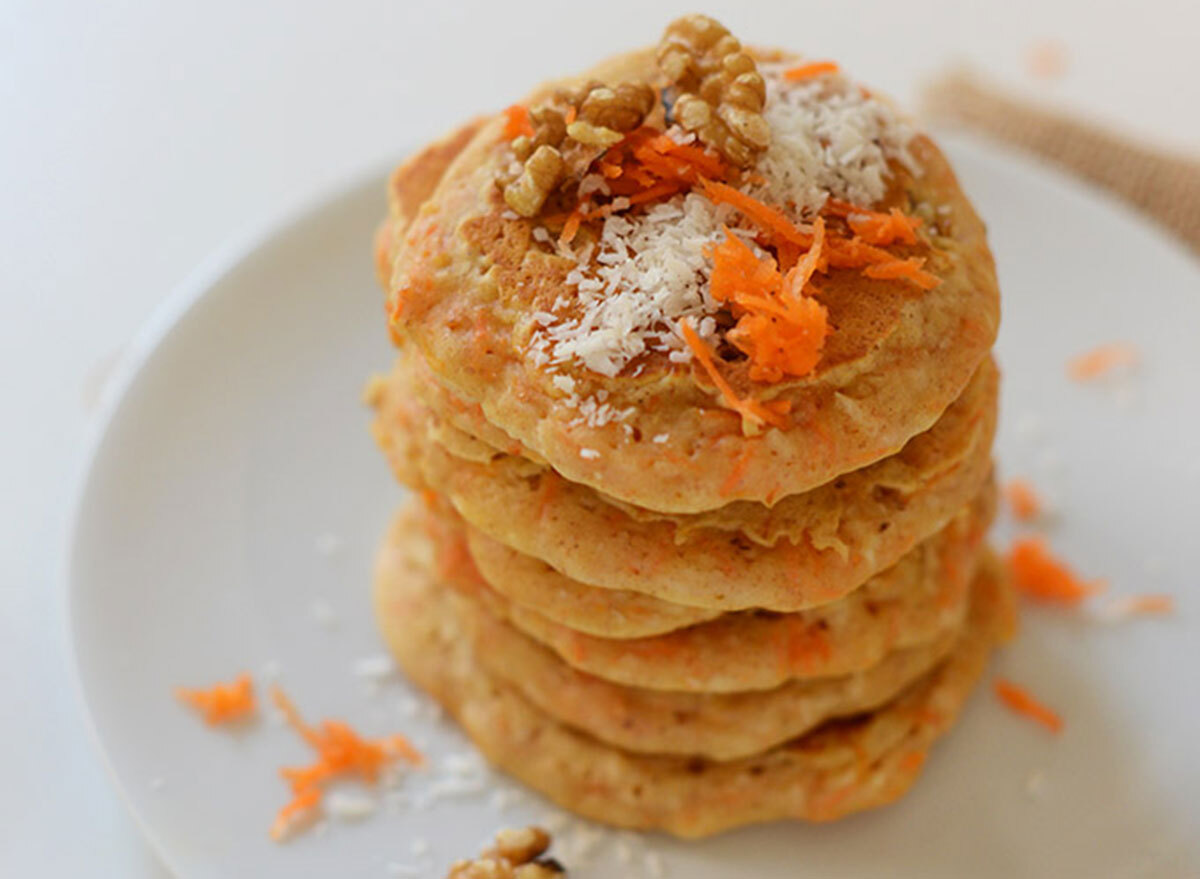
(368, 353, 997, 612)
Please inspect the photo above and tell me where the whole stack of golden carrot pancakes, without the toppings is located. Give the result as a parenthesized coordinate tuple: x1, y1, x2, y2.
(368, 41, 1012, 837)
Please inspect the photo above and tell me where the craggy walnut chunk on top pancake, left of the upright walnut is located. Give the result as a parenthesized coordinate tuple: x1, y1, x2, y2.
(498, 80, 658, 217)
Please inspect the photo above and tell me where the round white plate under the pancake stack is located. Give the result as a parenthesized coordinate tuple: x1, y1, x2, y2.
(70, 140, 1200, 879)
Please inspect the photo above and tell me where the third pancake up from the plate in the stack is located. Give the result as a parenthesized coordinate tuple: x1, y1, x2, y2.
(418, 480, 992, 693)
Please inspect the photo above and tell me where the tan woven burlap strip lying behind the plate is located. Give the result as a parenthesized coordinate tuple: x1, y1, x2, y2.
(922, 71, 1200, 255)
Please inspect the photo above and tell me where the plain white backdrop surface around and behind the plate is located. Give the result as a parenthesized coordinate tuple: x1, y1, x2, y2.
(0, 0, 1200, 877)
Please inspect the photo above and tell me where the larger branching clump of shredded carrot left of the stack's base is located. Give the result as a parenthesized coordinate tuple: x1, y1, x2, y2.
(271, 687, 425, 841)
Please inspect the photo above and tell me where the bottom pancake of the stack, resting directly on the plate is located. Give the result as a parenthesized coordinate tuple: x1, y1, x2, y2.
(374, 521, 1013, 837)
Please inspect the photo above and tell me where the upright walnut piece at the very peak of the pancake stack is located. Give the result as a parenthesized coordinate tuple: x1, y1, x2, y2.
(658, 16, 770, 168)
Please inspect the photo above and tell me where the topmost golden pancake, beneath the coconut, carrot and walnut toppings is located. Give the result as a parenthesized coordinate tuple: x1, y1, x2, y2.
(384, 50, 998, 513)
